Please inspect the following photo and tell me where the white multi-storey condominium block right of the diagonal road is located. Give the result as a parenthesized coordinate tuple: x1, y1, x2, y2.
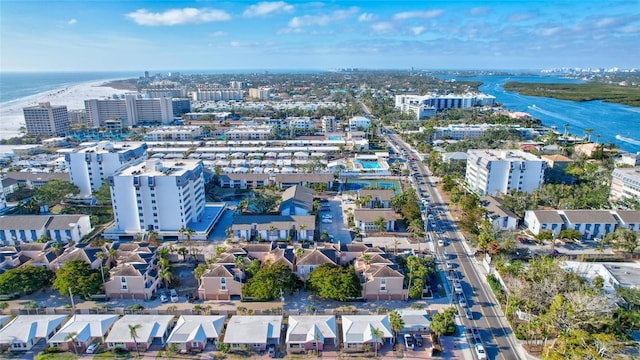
(465, 150, 546, 195)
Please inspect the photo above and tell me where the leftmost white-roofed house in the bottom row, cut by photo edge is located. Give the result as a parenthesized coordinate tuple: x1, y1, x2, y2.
(0, 315, 67, 351)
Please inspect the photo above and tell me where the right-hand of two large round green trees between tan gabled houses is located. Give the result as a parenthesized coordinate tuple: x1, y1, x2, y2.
(307, 264, 362, 301)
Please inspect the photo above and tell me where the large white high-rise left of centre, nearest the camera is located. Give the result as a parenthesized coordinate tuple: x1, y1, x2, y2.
(109, 159, 205, 234)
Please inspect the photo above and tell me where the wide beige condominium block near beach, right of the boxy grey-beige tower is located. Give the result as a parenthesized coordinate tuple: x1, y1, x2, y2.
(84, 94, 173, 127)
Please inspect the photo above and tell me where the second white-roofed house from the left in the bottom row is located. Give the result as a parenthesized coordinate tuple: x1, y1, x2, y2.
(48, 314, 120, 351)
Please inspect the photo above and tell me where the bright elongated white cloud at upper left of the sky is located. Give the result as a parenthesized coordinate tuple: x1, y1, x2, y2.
(125, 8, 231, 26)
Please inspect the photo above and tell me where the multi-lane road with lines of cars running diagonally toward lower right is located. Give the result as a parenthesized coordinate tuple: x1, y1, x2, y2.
(387, 134, 524, 360)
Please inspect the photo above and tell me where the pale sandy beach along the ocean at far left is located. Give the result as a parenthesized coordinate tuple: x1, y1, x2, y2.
(0, 80, 131, 139)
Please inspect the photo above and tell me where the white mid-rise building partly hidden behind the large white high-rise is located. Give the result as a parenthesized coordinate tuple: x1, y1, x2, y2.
(65, 141, 147, 196)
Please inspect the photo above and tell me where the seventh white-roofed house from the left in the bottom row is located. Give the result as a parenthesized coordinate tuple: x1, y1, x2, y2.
(342, 315, 393, 351)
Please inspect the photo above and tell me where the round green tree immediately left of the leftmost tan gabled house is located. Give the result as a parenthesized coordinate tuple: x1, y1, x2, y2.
(53, 260, 102, 299)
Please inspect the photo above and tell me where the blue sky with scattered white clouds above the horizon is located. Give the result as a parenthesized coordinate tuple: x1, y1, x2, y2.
(0, 0, 640, 71)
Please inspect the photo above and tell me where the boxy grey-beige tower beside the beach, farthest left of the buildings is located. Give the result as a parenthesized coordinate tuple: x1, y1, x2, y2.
(22, 102, 71, 136)
